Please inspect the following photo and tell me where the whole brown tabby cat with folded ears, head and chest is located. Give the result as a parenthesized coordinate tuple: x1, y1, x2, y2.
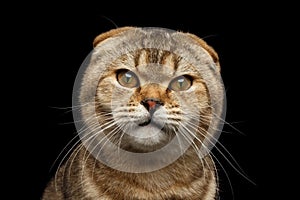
(42, 27, 225, 200)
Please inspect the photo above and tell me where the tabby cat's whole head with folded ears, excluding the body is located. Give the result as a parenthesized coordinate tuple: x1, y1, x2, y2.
(74, 27, 225, 172)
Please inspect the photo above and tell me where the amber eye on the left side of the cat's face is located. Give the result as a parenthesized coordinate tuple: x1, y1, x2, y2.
(117, 70, 139, 88)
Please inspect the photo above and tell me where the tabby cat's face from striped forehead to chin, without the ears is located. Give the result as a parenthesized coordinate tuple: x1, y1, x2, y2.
(96, 49, 211, 151)
